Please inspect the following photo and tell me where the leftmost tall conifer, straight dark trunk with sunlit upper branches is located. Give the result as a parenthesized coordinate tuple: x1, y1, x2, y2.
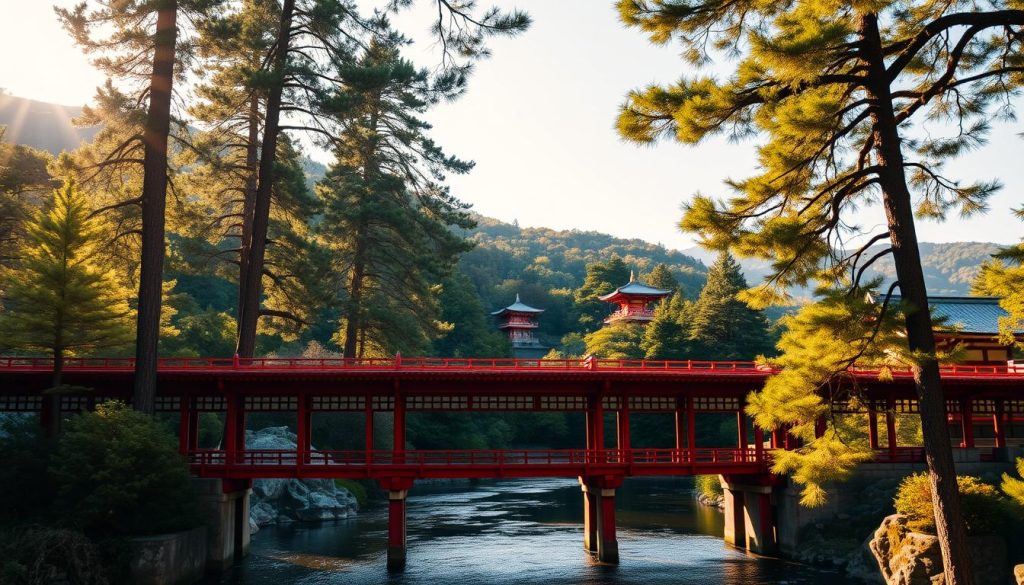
(56, 0, 222, 414)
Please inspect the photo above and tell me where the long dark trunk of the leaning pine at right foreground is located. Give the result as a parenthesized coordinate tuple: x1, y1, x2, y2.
(861, 14, 973, 585)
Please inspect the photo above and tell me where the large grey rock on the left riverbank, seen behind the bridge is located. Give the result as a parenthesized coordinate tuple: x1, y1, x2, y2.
(246, 426, 358, 532)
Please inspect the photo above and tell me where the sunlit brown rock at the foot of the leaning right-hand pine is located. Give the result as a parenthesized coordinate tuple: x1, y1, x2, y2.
(868, 514, 1009, 585)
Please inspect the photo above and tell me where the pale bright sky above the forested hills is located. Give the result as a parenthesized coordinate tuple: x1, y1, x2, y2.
(0, 0, 1024, 249)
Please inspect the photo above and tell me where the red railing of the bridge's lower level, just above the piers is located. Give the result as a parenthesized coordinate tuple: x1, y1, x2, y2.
(187, 448, 768, 467)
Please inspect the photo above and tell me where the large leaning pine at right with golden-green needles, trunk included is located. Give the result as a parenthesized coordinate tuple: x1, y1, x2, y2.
(618, 0, 1024, 585)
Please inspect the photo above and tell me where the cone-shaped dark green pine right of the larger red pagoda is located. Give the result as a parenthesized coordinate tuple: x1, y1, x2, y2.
(690, 253, 772, 360)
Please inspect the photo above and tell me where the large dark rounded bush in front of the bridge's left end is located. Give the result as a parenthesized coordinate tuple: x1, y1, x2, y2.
(49, 403, 202, 538)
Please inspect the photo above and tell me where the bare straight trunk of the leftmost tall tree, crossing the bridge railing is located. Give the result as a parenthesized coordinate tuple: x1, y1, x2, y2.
(132, 0, 178, 414)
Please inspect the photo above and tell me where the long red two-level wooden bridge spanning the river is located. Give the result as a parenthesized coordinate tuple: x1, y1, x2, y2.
(0, 358, 1024, 567)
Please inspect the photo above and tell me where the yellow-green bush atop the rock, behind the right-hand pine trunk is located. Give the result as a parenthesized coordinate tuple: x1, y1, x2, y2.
(895, 472, 1020, 534)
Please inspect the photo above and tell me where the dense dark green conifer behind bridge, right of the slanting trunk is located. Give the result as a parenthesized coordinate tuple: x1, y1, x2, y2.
(319, 41, 473, 358)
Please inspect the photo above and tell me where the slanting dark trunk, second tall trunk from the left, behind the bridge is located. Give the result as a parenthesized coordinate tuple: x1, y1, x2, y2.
(237, 0, 295, 358)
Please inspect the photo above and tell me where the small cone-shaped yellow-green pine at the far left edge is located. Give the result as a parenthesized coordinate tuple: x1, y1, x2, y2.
(0, 183, 132, 433)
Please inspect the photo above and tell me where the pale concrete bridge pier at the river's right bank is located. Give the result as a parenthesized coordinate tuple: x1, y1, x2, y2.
(721, 475, 778, 555)
